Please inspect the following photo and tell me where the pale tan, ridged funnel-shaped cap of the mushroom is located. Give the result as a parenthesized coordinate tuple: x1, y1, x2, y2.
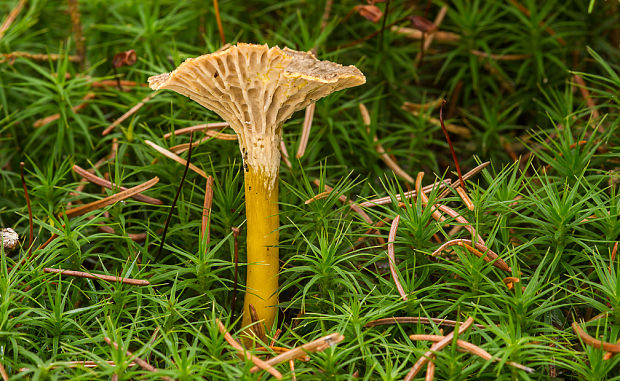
(149, 43, 366, 183)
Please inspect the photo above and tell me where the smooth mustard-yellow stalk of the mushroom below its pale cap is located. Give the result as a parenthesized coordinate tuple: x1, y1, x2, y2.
(242, 167, 280, 344)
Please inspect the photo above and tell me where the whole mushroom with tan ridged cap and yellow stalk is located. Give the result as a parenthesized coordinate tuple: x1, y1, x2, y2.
(148, 43, 366, 336)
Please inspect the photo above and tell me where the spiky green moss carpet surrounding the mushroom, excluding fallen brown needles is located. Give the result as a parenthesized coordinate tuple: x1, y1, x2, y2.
(0, 0, 620, 380)
